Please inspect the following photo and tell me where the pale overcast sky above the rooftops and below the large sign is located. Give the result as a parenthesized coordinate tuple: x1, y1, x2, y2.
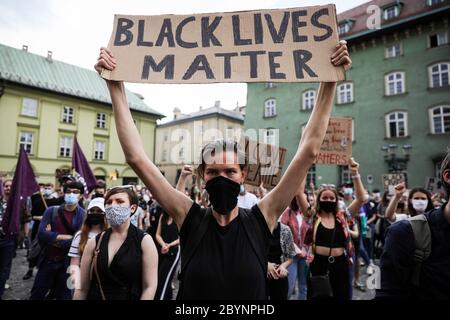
(0, 0, 367, 119)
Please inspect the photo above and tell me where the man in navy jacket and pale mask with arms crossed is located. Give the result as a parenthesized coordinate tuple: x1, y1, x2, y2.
(30, 182, 85, 300)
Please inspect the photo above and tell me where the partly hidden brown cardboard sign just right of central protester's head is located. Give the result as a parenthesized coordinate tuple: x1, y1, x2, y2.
(245, 139, 286, 189)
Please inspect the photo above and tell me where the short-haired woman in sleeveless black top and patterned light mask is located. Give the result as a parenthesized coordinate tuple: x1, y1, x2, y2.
(74, 186, 158, 300)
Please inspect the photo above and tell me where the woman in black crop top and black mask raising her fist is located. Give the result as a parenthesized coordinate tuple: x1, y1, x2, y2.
(297, 158, 364, 300)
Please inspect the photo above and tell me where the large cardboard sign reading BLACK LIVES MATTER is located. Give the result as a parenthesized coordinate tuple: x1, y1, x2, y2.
(102, 4, 345, 83)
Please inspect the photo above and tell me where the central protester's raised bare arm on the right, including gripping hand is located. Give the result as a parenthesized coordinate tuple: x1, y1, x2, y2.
(258, 41, 351, 230)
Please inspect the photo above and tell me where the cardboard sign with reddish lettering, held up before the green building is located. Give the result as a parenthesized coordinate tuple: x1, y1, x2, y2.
(315, 118, 353, 166)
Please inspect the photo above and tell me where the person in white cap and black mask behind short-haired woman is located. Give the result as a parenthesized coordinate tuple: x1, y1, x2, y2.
(68, 198, 108, 268)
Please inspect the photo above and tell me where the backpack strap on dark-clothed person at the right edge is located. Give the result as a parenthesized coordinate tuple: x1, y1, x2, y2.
(408, 214, 431, 287)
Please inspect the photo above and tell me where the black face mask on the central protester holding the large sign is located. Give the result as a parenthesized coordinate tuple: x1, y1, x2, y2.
(205, 176, 240, 215)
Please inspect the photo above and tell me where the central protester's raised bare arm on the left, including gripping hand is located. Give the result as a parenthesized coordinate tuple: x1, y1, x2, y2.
(95, 48, 192, 229)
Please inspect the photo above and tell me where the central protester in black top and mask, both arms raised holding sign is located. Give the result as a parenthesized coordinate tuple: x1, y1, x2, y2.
(95, 41, 351, 300)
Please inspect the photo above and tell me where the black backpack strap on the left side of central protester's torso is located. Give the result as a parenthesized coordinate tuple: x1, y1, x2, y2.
(177, 207, 212, 300)
